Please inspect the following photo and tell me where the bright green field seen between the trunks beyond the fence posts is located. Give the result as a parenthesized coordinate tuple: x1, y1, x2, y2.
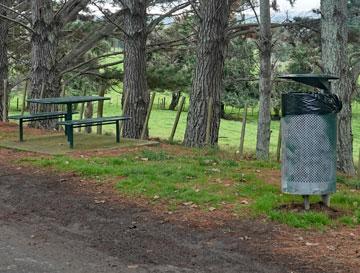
(4, 88, 360, 158)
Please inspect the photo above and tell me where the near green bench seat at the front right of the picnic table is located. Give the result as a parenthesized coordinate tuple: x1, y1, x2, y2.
(58, 116, 131, 148)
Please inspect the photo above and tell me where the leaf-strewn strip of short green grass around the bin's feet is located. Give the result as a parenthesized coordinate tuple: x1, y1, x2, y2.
(20, 145, 360, 229)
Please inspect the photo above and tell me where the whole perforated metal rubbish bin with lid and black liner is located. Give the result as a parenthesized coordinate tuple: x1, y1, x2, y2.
(280, 74, 342, 209)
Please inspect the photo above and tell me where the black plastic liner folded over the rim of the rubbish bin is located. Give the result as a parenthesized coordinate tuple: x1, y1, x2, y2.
(281, 92, 342, 117)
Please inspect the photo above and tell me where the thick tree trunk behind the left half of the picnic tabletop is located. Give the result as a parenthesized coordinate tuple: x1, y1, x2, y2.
(30, 0, 61, 128)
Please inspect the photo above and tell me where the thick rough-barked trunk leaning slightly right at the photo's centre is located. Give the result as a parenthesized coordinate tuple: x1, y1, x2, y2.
(184, 0, 230, 147)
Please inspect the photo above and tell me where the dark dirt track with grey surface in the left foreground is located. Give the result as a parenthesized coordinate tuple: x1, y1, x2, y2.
(0, 157, 348, 273)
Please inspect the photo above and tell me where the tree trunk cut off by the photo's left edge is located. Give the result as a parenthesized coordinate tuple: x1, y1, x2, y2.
(0, 0, 9, 120)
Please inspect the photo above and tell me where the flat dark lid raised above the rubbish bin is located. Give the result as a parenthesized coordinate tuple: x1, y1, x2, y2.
(278, 74, 339, 91)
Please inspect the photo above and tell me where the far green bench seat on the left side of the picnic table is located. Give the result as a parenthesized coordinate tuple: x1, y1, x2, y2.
(9, 111, 78, 141)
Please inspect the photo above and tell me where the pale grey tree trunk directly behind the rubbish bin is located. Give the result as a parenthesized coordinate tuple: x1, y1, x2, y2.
(321, 0, 355, 175)
